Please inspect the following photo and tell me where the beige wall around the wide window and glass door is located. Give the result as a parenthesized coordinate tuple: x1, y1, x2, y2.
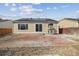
(13, 23, 48, 33)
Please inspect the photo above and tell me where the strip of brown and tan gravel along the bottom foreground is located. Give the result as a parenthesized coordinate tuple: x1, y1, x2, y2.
(0, 46, 79, 56)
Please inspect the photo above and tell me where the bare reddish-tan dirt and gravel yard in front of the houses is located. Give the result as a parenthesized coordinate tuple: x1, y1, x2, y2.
(0, 33, 79, 56)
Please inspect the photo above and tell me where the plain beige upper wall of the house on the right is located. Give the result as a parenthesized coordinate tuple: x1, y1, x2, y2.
(57, 20, 78, 28)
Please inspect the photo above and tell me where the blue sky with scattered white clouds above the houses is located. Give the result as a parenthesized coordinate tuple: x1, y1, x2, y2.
(0, 3, 79, 20)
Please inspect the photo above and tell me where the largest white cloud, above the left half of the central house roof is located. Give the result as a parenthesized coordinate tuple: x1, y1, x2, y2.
(19, 5, 43, 14)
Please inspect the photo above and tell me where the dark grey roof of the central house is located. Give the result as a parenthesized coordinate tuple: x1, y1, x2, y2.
(13, 18, 58, 23)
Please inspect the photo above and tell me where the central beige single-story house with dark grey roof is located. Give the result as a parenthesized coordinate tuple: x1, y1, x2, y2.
(13, 18, 58, 34)
